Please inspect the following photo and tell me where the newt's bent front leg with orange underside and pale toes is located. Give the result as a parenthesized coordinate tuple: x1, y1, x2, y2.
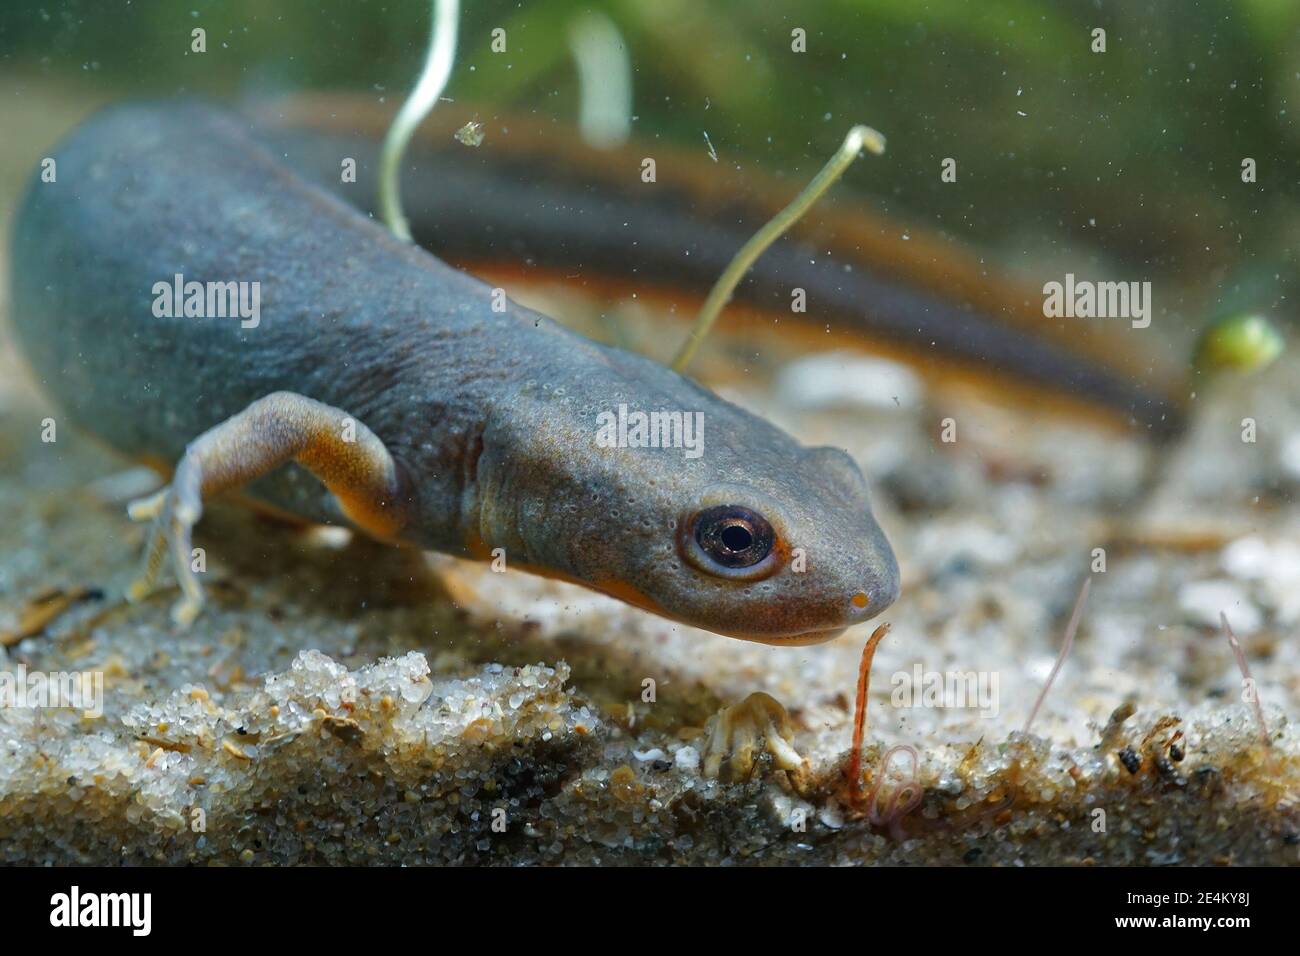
(126, 392, 410, 627)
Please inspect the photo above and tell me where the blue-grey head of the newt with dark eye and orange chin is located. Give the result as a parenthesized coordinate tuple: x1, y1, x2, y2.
(480, 352, 898, 644)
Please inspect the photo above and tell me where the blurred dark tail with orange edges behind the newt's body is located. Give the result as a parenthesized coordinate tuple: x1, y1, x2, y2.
(259, 95, 1188, 441)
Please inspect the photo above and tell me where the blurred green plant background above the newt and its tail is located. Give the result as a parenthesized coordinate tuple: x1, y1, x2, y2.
(0, 0, 1300, 323)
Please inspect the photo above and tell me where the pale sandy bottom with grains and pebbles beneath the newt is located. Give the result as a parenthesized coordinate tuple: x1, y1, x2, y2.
(0, 89, 1300, 865)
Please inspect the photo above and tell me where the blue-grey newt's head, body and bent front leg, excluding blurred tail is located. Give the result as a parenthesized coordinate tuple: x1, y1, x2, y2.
(12, 103, 900, 645)
